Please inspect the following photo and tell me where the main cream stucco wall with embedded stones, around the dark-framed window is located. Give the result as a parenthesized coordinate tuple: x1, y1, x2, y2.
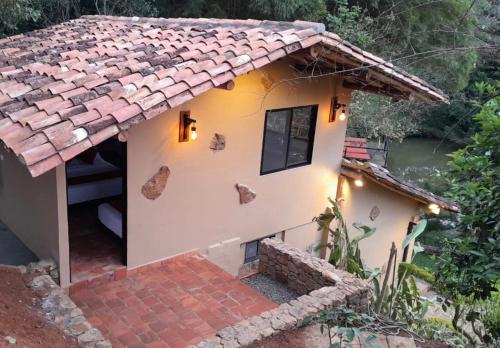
(128, 61, 350, 273)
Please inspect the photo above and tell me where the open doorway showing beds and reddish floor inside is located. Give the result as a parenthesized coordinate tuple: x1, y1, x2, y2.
(66, 139, 127, 283)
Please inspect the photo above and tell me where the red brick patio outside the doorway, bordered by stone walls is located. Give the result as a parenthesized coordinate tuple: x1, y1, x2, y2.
(71, 254, 277, 348)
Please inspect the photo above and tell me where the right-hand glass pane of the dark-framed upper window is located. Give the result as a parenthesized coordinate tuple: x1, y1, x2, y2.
(288, 106, 313, 166)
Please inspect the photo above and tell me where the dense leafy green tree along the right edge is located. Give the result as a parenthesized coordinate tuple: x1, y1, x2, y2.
(435, 81, 500, 342)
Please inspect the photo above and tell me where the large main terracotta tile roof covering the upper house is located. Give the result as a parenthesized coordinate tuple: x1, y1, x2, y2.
(0, 16, 447, 176)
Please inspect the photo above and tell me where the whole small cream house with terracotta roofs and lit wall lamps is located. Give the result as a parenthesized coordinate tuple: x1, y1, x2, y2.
(0, 16, 455, 287)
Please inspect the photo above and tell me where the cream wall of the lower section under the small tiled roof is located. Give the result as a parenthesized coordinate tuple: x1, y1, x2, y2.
(341, 178, 421, 268)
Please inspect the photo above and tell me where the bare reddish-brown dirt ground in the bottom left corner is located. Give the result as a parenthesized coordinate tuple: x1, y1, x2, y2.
(0, 268, 78, 348)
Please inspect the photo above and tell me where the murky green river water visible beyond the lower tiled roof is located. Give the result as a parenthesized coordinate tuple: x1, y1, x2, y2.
(387, 138, 458, 187)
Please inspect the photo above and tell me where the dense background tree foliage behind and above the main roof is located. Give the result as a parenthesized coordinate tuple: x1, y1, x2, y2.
(0, 0, 500, 142)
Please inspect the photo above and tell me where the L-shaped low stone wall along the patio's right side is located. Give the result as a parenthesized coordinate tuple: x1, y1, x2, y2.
(195, 239, 370, 348)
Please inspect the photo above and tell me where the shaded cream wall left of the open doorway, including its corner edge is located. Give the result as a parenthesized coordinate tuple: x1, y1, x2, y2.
(0, 149, 69, 285)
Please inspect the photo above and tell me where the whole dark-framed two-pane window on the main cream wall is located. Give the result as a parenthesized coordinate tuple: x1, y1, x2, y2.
(260, 105, 318, 174)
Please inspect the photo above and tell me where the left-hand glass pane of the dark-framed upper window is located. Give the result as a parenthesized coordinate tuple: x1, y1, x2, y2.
(262, 110, 291, 172)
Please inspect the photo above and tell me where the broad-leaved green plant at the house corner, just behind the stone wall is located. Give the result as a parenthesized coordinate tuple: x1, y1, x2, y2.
(313, 199, 375, 278)
